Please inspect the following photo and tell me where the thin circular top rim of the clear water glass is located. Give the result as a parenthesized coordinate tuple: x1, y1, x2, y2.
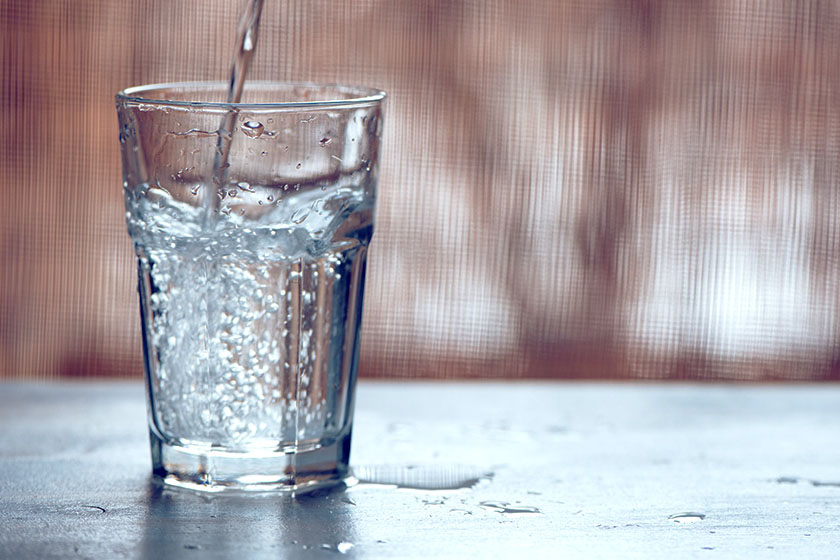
(115, 80, 386, 110)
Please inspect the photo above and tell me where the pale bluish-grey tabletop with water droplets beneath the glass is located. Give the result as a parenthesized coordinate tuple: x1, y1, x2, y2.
(0, 381, 840, 558)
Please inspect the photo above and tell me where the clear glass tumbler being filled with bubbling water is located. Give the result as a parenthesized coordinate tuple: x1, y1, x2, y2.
(116, 82, 385, 491)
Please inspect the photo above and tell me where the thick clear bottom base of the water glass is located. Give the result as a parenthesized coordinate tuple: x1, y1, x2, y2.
(150, 430, 350, 494)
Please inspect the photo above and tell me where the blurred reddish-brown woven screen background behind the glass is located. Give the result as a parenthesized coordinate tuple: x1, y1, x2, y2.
(0, 0, 840, 380)
